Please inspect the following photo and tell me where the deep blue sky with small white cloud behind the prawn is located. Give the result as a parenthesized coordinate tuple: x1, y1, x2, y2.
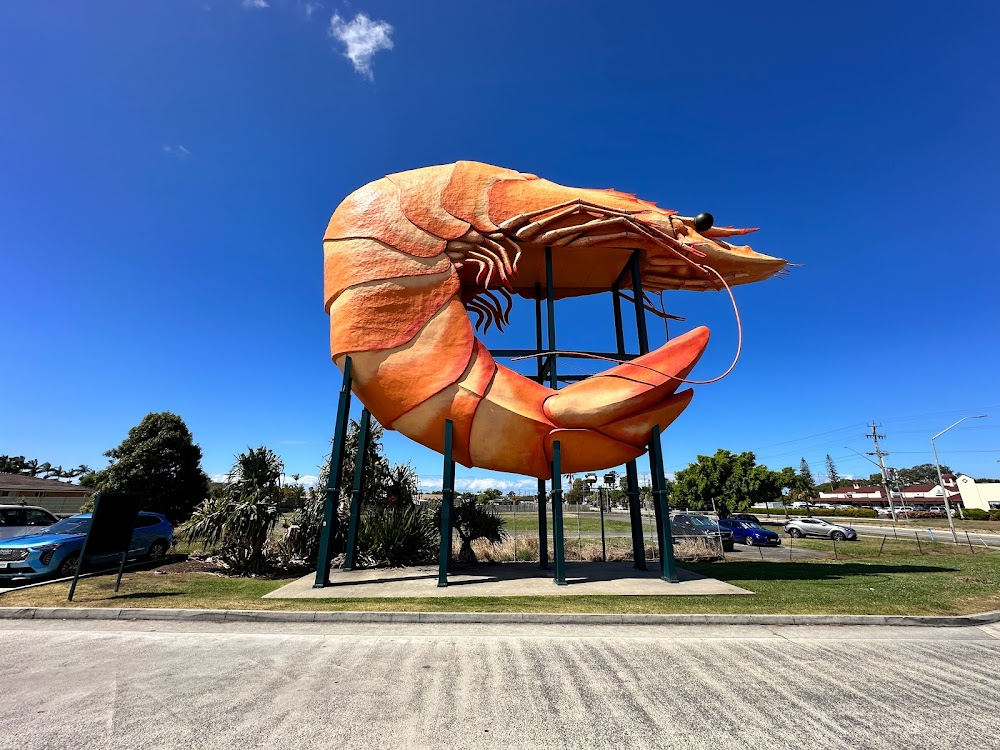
(0, 0, 1000, 489)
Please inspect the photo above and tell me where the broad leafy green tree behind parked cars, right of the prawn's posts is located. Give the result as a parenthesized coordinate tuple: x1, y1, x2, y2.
(671, 448, 782, 518)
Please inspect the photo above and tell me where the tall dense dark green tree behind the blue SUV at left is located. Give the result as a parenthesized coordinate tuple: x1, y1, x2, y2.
(89, 411, 208, 523)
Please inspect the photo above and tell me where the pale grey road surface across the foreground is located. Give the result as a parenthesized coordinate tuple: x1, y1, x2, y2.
(0, 620, 1000, 750)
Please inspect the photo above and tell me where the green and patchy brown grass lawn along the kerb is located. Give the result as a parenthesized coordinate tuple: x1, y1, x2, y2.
(0, 552, 1000, 615)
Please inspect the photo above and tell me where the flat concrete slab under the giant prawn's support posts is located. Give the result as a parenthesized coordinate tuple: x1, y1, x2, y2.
(264, 562, 753, 599)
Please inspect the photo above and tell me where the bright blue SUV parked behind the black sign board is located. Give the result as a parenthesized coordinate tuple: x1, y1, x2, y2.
(0, 513, 174, 580)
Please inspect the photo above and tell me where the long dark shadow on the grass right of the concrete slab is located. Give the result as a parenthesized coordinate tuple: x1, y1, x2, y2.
(684, 560, 960, 581)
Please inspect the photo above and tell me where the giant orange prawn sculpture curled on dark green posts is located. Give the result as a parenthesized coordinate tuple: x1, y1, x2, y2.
(324, 161, 786, 479)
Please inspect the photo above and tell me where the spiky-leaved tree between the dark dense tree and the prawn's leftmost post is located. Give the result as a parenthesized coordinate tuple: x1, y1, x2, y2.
(181, 446, 284, 575)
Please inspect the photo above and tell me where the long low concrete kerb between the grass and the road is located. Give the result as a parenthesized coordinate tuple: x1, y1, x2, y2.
(0, 607, 1000, 627)
